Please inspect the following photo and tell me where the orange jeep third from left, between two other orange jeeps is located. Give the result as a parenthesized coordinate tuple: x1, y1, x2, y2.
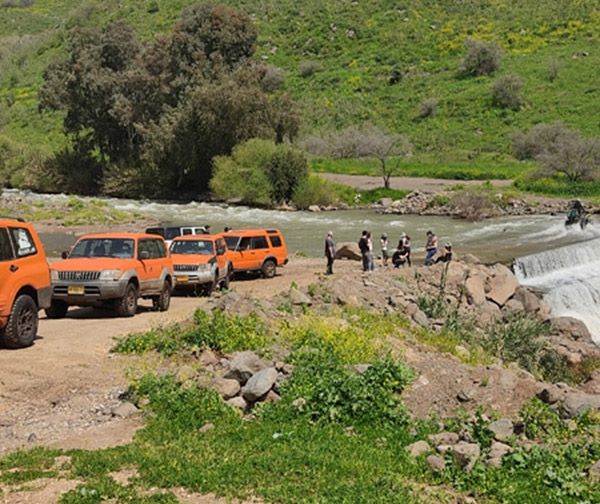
(170, 234, 233, 296)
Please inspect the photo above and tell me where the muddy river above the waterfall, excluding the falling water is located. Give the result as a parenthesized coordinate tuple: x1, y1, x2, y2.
(28, 195, 600, 263)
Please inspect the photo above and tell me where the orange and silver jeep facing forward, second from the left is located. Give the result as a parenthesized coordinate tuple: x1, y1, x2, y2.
(46, 233, 173, 318)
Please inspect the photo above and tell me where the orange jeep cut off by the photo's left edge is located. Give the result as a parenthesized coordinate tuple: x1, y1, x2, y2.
(0, 217, 51, 348)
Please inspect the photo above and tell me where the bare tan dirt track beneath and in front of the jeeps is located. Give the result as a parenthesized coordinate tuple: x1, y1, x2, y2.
(0, 259, 342, 453)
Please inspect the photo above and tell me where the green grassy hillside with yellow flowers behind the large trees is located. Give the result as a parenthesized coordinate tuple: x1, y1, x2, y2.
(0, 0, 600, 184)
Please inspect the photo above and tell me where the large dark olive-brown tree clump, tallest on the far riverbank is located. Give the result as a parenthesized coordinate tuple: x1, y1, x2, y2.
(40, 5, 300, 197)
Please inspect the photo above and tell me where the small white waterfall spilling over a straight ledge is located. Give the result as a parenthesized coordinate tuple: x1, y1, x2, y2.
(514, 238, 600, 345)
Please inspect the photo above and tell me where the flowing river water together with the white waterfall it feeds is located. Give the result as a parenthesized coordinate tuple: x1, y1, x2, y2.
(11, 189, 600, 338)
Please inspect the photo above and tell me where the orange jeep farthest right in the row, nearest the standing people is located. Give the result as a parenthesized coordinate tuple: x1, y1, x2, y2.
(223, 229, 288, 278)
